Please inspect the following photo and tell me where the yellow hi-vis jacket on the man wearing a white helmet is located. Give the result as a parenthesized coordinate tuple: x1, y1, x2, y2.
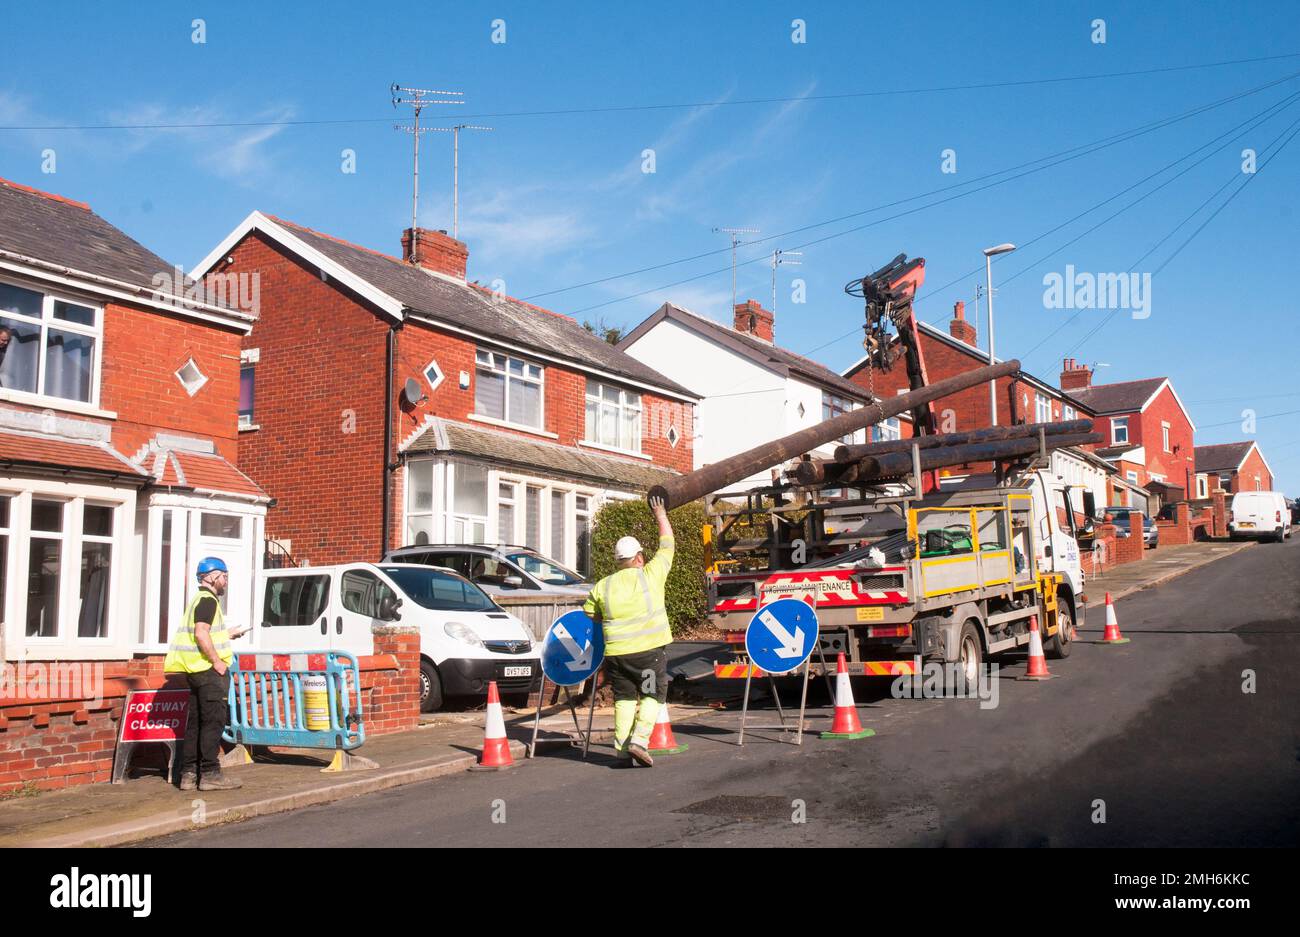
(582, 537, 673, 656)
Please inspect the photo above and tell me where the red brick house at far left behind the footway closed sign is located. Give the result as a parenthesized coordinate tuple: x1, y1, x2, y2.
(0, 181, 268, 791)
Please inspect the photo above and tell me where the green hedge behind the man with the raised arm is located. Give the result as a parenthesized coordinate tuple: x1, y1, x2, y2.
(592, 499, 709, 633)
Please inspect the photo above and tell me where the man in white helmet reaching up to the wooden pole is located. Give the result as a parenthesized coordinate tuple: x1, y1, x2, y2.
(582, 498, 673, 765)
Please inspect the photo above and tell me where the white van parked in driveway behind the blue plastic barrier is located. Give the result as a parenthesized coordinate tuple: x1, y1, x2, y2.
(254, 563, 542, 712)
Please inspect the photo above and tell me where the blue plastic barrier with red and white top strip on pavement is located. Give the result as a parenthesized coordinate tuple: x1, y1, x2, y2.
(221, 651, 365, 751)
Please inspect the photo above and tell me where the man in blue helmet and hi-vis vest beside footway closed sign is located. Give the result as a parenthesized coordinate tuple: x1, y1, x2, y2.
(163, 556, 248, 790)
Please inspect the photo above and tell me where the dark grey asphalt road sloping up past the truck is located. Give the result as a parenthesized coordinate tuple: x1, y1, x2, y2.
(151, 538, 1300, 847)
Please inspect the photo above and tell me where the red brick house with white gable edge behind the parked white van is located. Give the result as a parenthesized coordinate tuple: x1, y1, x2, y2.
(195, 212, 696, 572)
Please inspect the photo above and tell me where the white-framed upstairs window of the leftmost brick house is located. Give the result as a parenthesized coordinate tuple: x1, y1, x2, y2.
(0, 282, 103, 404)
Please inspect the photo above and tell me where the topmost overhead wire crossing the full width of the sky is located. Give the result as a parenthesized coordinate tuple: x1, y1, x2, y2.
(0, 52, 1300, 131)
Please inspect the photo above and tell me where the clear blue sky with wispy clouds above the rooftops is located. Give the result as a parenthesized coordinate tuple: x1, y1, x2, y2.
(0, 0, 1300, 495)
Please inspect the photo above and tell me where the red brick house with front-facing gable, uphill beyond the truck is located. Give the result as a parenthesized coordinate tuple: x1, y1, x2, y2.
(1061, 359, 1196, 502)
